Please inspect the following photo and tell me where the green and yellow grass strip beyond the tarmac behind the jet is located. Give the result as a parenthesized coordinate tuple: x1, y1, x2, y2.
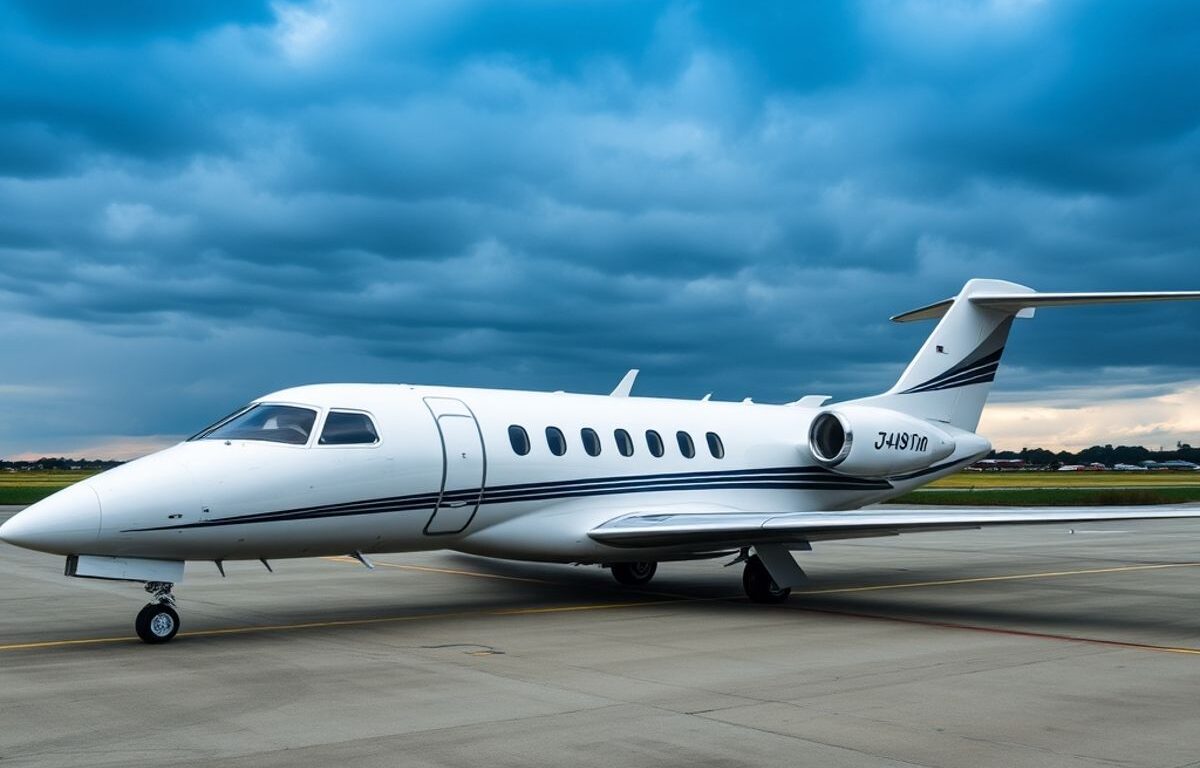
(0, 469, 1200, 506)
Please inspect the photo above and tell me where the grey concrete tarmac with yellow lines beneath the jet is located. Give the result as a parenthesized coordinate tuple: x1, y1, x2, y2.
(0, 508, 1200, 768)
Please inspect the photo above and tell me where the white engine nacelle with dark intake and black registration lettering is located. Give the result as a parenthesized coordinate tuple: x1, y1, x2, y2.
(809, 406, 954, 478)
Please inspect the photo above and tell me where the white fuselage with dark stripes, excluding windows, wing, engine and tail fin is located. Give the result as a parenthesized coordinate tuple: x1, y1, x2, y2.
(9, 384, 988, 563)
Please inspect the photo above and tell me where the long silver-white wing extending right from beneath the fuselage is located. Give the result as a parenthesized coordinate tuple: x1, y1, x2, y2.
(588, 506, 1200, 548)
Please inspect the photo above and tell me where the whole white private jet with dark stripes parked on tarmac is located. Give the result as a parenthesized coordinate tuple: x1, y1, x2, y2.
(0, 280, 1200, 643)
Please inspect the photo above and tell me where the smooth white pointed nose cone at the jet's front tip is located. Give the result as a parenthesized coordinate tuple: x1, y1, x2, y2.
(0, 482, 100, 554)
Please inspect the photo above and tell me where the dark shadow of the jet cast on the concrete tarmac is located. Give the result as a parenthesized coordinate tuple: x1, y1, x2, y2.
(231, 553, 1200, 646)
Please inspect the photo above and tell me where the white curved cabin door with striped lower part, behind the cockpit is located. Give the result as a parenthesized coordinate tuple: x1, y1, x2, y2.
(425, 397, 487, 534)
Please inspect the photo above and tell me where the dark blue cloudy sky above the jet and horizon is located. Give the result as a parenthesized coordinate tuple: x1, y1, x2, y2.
(0, 0, 1200, 458)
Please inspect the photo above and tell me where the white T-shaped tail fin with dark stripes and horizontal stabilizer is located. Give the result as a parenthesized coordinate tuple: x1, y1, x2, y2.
(863, 278, 1200, 432)
